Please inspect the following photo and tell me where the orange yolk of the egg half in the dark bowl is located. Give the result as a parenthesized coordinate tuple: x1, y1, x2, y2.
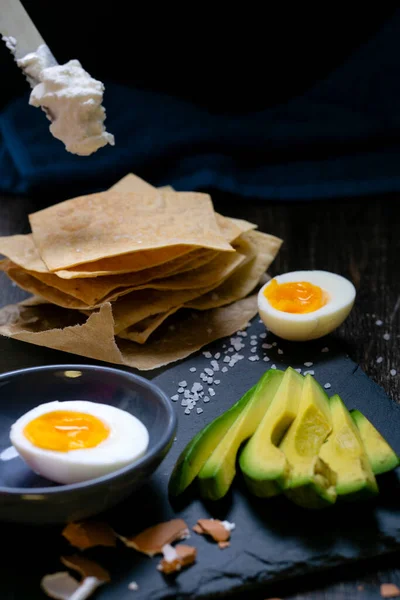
(24, 410, 110, 452)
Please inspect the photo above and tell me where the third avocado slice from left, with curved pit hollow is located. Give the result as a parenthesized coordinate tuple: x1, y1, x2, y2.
(239, 367, 304, 498)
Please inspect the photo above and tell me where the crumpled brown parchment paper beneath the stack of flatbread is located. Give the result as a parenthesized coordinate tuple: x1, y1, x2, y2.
(0, 294, 257, 371)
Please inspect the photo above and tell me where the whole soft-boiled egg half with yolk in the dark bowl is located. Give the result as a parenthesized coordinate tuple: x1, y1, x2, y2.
(10, 400, 149, 484)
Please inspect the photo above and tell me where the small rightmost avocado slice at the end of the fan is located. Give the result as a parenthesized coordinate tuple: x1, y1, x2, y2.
(350, 410, 400, 475)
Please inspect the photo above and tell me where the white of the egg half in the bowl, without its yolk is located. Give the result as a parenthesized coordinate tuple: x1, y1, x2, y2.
(10, 400, 149, 484)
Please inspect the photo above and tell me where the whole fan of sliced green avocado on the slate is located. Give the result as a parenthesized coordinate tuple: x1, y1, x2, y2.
(168, 360, 400, 509)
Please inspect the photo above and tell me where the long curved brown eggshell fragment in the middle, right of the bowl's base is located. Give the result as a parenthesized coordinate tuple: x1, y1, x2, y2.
(119, 519, 189, 556)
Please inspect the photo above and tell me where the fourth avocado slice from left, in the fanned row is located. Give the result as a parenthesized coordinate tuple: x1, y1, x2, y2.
(279, 375, 336, 508)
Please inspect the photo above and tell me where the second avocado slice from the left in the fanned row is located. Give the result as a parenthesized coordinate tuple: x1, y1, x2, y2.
(198, 369, 284, 500)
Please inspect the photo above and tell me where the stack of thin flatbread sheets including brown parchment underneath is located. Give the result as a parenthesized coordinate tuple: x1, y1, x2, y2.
(0, 174, 282, 370)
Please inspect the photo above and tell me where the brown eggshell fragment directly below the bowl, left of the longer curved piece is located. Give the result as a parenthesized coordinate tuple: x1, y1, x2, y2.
(62, 521, 116, 550)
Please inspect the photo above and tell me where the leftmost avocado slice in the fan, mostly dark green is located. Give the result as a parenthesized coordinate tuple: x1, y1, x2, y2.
(168, 384, 257, 496)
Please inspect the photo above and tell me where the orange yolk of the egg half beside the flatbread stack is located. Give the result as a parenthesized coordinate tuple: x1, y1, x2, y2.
(264, 279, 328, 314)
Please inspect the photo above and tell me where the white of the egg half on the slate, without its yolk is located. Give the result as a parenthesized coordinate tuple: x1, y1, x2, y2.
(258, 271, 356, 341)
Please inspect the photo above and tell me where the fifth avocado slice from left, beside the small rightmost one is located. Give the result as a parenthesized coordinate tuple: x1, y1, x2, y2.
(319, 394, 379, 500)
